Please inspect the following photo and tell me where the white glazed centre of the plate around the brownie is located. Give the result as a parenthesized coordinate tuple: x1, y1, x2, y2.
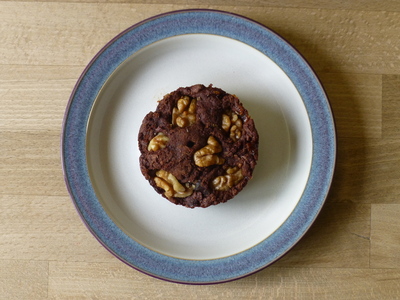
(87, 34, 312, 259)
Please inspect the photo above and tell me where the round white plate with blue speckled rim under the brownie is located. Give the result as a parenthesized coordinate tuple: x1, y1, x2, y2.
(61, 10, 336, 284)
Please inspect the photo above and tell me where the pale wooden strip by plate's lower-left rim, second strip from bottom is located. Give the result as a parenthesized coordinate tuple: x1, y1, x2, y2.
(0, 195, 116, 262)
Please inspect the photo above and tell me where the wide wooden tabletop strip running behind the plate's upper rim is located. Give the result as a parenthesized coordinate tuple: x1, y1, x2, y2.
(0, 2, 400, 74)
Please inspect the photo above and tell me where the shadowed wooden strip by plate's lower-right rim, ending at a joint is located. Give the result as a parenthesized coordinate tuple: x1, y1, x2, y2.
(276, 203, 371, 268)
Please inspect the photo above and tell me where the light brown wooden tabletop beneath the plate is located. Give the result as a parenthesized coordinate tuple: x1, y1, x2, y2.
(0, 0, 400, 299)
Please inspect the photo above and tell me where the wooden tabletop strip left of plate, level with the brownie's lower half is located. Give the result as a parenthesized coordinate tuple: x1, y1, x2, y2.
(0, 131, 66, 195)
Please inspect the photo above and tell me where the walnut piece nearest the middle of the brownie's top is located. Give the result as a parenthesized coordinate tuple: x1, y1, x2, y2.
(194, 136, 225, 167)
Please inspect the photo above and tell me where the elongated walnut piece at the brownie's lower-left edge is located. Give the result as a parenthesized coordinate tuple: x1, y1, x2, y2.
(154, 170, 194, 198)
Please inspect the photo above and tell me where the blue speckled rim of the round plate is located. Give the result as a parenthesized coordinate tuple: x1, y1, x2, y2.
(61, 9, 336, 284)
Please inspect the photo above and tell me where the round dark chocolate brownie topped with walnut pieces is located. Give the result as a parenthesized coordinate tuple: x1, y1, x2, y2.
(138, 84, 258, 208)
